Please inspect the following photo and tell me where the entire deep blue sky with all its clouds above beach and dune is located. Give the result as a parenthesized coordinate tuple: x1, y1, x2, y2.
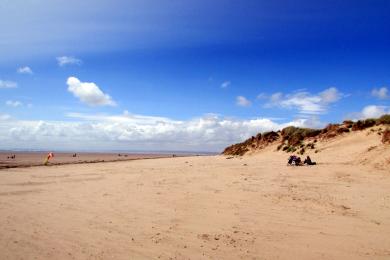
(0, 0, 390, 151)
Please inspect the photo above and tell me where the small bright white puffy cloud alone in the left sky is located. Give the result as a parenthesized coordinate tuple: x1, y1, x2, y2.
(66, 77, 116, 106)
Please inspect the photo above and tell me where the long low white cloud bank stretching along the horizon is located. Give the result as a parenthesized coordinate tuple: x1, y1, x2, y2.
(0, 111, 314, 152)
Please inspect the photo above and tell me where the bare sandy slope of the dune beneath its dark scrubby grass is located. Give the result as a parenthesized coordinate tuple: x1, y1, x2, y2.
(238, 126, 390, 170)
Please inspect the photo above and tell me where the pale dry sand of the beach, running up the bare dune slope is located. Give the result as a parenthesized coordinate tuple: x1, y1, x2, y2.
(0, 131, 390, 259)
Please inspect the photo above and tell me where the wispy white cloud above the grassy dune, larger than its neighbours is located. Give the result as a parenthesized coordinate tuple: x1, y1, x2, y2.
(265, 87, 342, 115)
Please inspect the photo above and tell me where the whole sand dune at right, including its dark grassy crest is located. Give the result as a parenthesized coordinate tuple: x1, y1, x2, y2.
(223, 116, 390, 169)
